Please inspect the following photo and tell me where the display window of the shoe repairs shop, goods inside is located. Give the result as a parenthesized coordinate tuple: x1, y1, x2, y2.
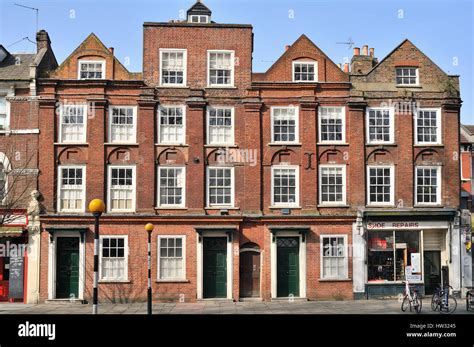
(368, 231, 422, 282)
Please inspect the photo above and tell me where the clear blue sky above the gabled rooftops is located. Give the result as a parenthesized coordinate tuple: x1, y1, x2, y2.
(0, 0, 474, 124)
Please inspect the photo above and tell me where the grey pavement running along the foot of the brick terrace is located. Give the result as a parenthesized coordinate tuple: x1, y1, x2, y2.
(0, 299, 474, 316)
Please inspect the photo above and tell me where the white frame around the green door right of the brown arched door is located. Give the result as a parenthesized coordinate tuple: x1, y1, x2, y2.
(269, 230, 307, 299)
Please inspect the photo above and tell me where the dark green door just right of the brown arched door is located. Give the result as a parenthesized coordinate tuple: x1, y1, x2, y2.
(277, 237, 300, 297)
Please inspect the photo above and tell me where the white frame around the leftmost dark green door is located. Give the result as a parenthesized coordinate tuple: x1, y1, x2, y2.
(48, 231, 86, 300)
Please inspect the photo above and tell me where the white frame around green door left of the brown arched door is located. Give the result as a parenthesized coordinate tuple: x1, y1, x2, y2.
(196, 230, 234, 300)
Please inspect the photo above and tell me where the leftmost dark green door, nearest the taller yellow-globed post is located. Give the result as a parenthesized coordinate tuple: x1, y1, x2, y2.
(56, 237, 79, 299)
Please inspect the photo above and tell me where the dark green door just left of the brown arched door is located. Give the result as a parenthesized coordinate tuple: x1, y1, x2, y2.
(203, 237, 227, 298)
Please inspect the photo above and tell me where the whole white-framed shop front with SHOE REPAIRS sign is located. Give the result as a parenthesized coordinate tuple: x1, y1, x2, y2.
(354, 212, 459, 298)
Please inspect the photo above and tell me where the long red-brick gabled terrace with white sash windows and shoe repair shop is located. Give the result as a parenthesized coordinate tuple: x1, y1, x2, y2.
(38, 1, 461, 302)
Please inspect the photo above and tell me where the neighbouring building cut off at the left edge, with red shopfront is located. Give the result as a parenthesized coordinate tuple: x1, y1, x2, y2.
(0, 31, 57, 303)
